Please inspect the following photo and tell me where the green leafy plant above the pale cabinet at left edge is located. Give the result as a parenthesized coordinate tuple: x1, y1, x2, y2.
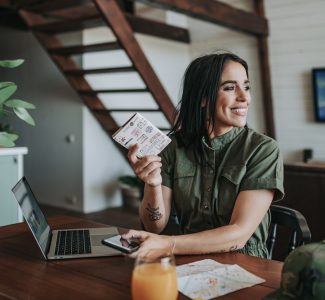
(0, 59, 35, 147)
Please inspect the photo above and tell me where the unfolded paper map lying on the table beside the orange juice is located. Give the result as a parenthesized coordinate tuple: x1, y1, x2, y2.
(176, 259, 265, 300)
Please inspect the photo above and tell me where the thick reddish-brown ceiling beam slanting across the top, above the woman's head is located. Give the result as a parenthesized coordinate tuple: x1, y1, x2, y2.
(133, 0, 268, 36)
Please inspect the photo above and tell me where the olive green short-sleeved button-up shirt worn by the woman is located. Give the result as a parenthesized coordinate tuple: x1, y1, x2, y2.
(161, 128, 284, 257)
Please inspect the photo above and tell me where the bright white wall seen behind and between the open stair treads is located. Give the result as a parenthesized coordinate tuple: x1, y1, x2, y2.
(83, 27, 189, 212)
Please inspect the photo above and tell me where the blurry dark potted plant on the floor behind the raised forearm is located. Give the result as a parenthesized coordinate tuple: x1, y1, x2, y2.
(118, 175, 144, 211)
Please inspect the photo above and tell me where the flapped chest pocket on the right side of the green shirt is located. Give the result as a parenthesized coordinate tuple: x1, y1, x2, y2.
(218, 165, 246, 222)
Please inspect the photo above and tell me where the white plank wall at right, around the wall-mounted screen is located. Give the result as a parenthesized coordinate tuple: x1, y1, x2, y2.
(265, 0, 325, 162)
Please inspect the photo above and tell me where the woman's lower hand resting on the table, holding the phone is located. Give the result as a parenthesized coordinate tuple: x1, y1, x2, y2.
(122, 230, 174, 259)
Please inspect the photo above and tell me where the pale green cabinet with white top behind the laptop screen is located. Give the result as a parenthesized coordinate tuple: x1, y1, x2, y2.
(0, 147, 27, 226)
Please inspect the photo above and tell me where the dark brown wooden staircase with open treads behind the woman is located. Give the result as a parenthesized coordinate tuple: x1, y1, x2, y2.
(18, 0, 178, 155)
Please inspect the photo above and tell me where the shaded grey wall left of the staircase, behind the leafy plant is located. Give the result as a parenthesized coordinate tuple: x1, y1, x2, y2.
(0, 27, 83, 210)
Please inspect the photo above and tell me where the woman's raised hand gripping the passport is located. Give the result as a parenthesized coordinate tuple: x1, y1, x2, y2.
(128, 144, 162, 187)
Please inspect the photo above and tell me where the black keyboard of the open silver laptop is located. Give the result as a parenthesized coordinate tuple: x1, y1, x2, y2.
(55, 229, 91, 255)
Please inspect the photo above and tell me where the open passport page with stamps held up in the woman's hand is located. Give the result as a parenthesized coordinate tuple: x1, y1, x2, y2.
(113, 113, 171, 157)
